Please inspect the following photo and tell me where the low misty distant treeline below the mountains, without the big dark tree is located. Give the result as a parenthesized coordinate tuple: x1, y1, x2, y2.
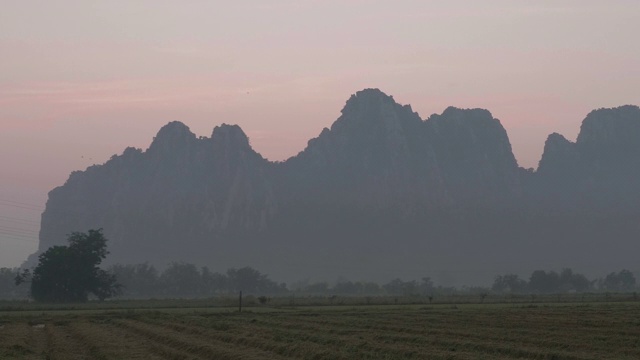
(0, 263, 638, 299)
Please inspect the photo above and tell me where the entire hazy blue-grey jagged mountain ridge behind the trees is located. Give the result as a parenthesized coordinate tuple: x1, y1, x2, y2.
(31, 89, 640, 281)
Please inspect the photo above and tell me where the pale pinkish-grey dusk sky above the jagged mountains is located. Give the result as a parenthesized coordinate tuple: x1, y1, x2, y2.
(0, 0, 640, 267)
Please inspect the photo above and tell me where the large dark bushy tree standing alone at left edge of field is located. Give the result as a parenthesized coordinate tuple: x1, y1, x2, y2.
(31, 229, 121, 302)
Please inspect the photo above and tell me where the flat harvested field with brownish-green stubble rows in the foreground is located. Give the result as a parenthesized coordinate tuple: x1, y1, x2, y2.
(0, 302, 640, 360)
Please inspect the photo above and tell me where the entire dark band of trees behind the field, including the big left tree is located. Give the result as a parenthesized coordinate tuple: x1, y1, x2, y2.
(0, 229, 639, 305)
